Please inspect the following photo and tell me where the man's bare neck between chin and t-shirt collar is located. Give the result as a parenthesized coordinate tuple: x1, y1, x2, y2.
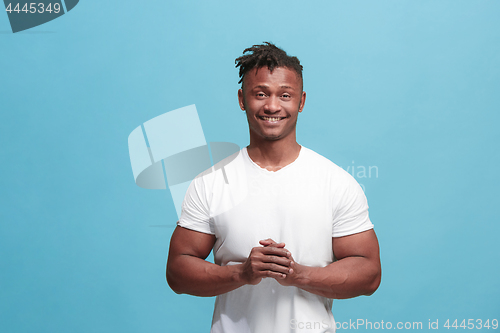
(247, 140, 301, 171)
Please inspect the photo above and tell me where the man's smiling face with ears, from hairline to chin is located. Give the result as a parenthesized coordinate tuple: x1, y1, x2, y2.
(238, 67, 306, 141)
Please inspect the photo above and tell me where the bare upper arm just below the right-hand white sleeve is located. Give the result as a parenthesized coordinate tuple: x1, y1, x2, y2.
(332, 229, 380, 261)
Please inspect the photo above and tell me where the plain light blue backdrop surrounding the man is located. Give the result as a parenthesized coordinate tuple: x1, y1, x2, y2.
(0, 0, 500, 332)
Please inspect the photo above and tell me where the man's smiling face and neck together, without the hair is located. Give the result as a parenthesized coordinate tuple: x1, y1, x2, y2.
(238, 67, 306, 171)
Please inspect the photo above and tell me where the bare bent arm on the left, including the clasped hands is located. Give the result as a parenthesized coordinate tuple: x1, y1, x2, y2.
(166, 227, 292, 296)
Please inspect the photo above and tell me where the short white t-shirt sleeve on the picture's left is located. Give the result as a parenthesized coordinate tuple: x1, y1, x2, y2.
(177, 177, 215, 235)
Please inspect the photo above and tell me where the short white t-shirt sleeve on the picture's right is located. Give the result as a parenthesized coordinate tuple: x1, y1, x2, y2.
(332, 175, 373, 237)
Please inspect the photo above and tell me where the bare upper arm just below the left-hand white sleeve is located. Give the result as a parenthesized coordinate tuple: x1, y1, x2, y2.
(169, 226, 215, 259)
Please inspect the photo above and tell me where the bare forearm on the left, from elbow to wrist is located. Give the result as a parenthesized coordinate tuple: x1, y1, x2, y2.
(167, 255, 245, 297)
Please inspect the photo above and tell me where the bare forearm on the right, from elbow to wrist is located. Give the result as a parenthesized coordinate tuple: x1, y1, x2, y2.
(286, 257, 381, 299)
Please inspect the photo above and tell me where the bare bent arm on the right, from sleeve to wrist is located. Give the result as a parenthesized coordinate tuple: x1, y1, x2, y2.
(267, 229, 381, 299)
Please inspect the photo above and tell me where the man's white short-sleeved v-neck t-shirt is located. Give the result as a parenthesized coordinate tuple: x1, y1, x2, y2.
(178, 147, 373, 333)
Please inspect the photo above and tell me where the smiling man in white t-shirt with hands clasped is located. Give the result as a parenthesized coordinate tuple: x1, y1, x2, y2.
(167, 43, 381, 333)
